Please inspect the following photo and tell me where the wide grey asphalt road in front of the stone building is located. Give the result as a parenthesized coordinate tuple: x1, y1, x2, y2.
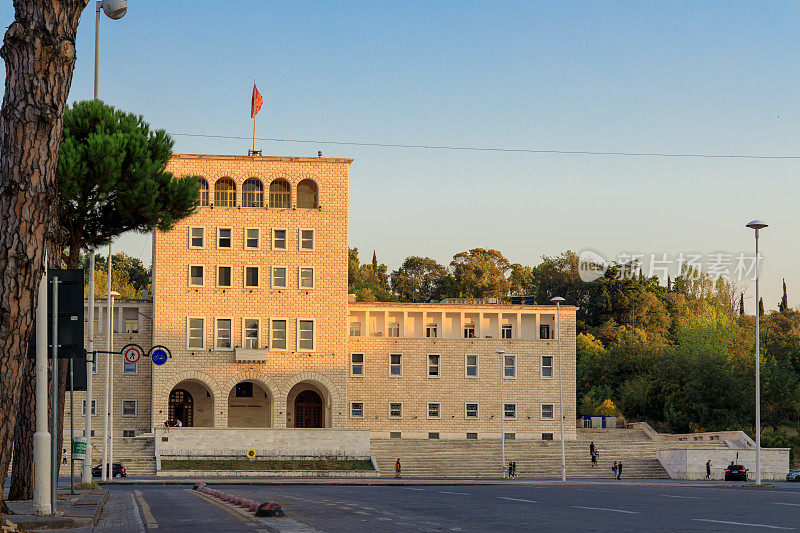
(104, 481, 800, 533)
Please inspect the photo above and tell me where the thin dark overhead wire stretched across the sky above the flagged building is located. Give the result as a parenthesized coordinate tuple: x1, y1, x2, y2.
(170, 133, 800, 160)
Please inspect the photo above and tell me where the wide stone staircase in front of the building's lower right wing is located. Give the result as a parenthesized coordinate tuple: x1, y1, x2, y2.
(371, 429, 727, 479)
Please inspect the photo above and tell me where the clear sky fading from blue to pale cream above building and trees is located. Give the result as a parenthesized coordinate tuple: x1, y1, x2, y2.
(0, 0, 800, 310)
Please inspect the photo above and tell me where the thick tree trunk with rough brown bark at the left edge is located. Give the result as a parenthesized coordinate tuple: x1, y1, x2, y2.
(0, 0, 88, 511)
